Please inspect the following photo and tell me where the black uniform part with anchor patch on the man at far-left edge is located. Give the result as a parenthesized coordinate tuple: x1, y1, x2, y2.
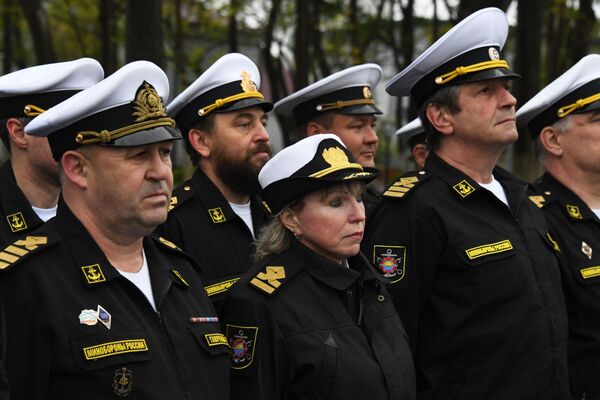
(0, 161, 44, 245)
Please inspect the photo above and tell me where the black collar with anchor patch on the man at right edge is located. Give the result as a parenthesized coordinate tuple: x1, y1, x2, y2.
(536, 172, 597, 222)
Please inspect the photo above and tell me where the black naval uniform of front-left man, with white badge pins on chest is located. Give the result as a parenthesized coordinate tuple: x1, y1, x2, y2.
(0, 204, 229, 400)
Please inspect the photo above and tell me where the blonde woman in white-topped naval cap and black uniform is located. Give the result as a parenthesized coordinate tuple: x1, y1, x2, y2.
(220, 134, 415, 400)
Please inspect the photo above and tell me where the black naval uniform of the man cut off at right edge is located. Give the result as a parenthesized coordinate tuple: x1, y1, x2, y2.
(530, 173, 600, 400)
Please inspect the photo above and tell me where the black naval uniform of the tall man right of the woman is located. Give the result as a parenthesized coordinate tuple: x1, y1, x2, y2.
(363, 154, 568, 400)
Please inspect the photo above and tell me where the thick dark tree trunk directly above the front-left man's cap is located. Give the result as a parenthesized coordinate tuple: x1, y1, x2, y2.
(125, 0, 165, 68)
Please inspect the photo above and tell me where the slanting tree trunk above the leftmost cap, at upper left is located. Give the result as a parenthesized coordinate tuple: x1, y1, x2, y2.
(20, 0, 56, 64)
